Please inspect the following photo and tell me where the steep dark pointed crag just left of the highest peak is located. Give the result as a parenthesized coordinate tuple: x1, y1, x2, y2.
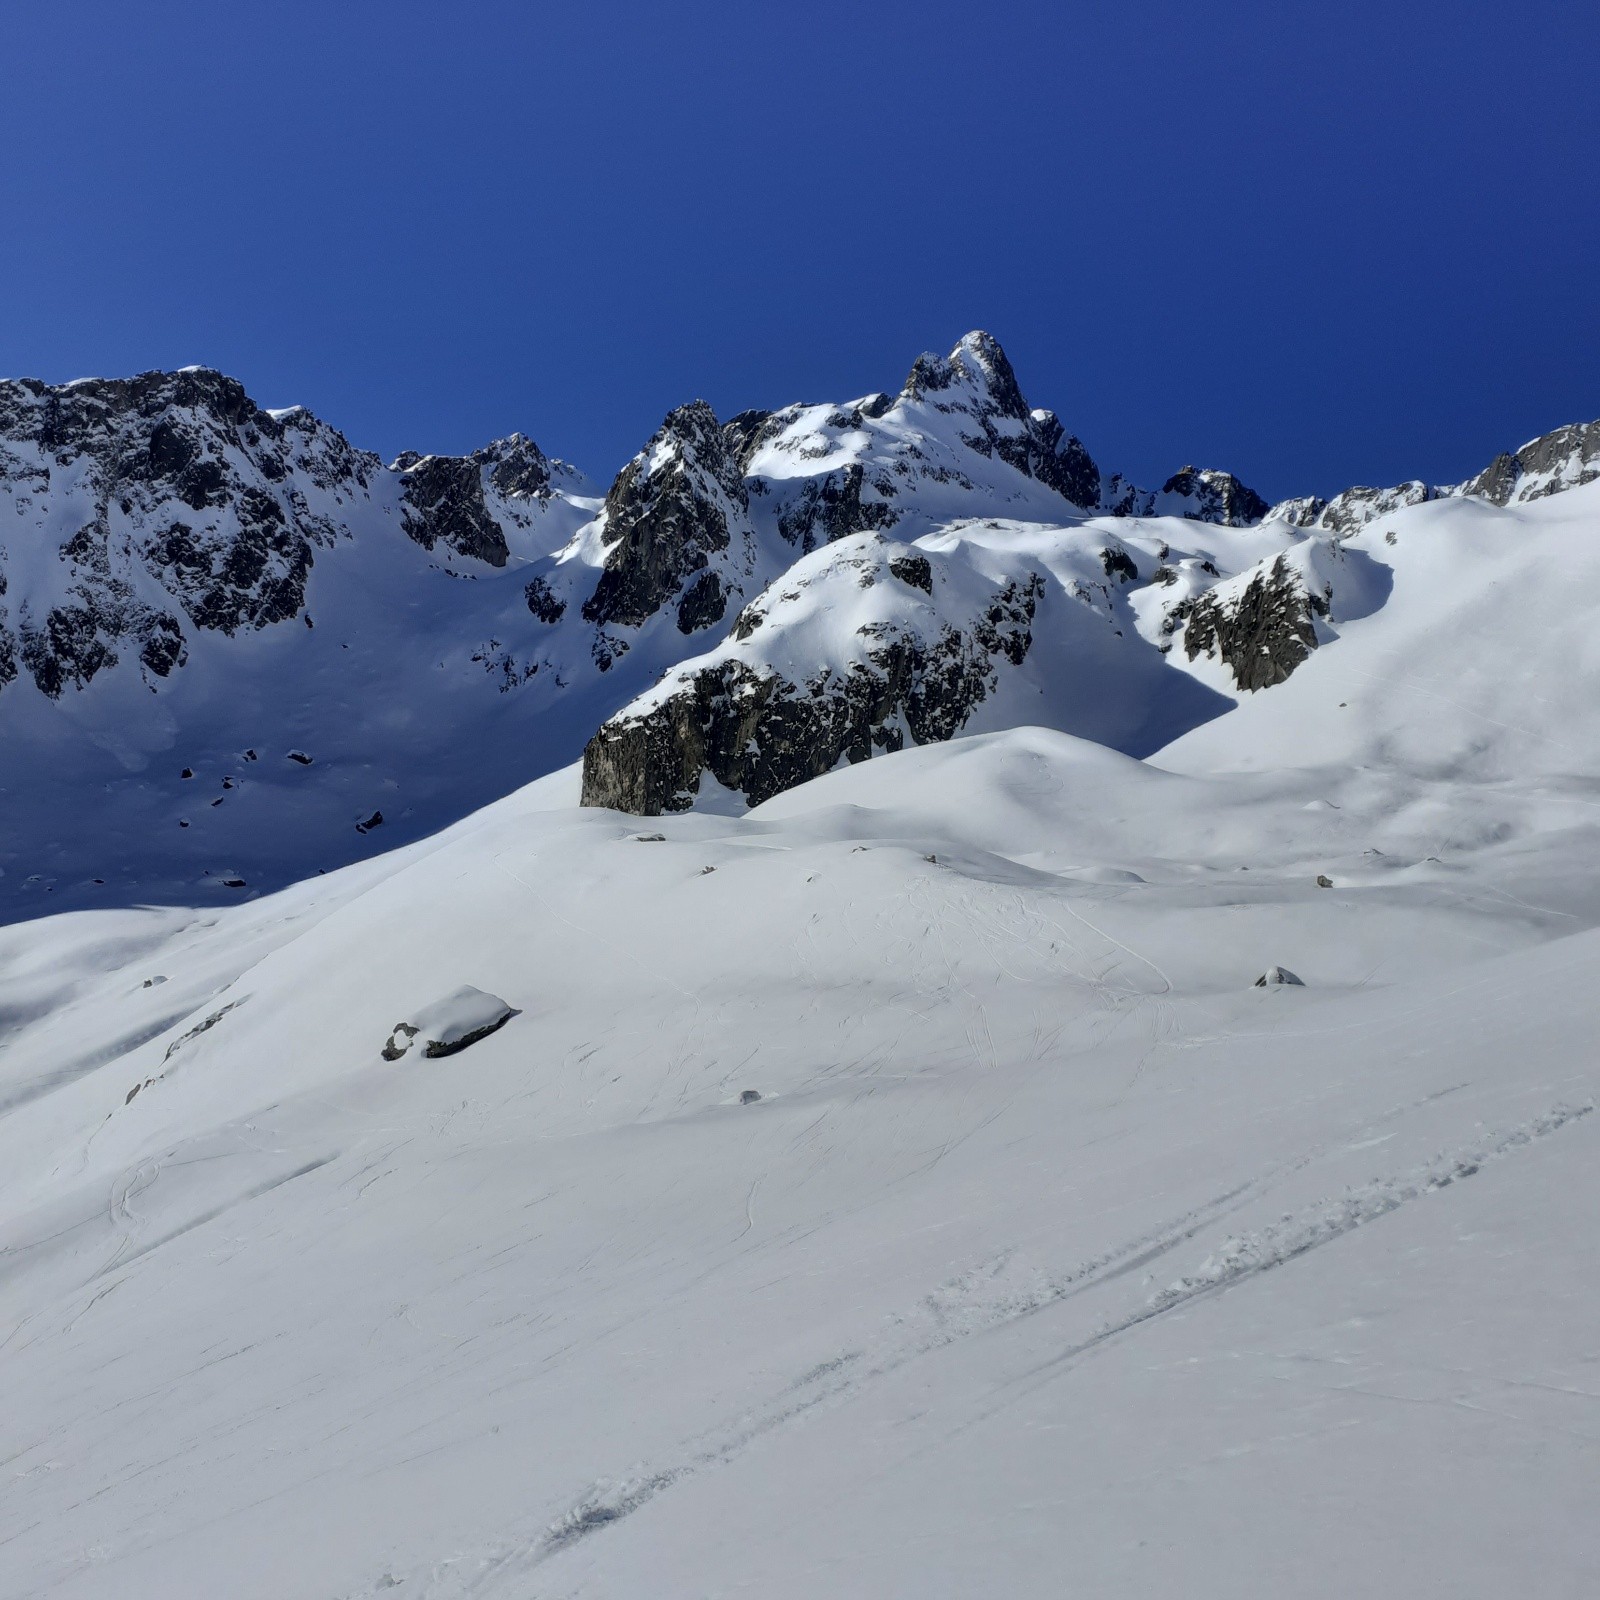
(582, 400, 749, 632)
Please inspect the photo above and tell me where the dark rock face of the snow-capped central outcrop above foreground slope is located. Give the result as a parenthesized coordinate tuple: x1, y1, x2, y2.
(582, 574, 1043, 816)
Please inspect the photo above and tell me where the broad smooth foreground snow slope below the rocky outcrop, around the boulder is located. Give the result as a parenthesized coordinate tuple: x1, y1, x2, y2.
(0, 729, 1600, 1600)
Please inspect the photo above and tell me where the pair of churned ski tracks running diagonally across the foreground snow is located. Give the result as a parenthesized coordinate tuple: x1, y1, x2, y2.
(371, 1096, 1594, 1600)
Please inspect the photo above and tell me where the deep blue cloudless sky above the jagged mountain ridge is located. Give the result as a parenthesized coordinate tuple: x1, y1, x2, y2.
(0, 0, 1600, 498)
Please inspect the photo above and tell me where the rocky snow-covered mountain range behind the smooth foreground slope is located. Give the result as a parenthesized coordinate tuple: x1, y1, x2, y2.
(0, 333, 1600, 915)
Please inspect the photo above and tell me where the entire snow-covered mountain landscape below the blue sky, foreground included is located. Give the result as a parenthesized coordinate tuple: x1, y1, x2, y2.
(0, 336, 1600, 1600)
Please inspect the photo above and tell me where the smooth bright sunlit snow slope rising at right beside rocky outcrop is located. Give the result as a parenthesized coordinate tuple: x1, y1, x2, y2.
(1157, 483, 1600, 789)
